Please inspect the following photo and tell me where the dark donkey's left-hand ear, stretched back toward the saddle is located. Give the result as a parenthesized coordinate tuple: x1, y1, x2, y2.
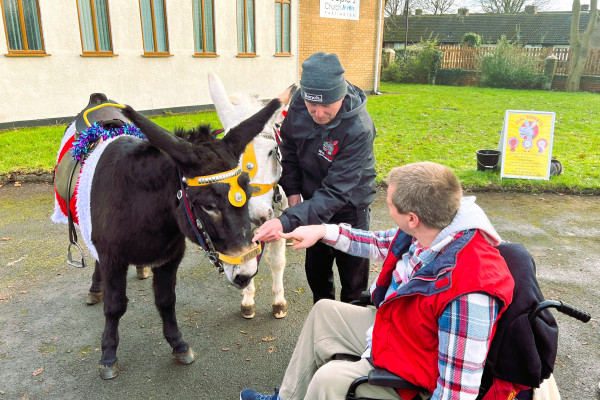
(121, 106, 193, 164)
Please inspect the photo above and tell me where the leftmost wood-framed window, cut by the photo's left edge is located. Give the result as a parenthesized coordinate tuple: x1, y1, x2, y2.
(2, 0, 46, 55)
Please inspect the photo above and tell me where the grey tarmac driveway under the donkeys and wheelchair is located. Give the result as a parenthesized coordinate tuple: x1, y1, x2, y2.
(0, 183, 600, 400)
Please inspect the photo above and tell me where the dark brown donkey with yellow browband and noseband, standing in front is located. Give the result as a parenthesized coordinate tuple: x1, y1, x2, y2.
(52, 86, 289, 379)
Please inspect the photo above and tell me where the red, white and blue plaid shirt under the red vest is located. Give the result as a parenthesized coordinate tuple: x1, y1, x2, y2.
(323, 224, 499, 400)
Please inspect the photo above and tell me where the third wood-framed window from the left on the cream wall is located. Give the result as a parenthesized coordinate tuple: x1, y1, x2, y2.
(140, 0, 169, 56)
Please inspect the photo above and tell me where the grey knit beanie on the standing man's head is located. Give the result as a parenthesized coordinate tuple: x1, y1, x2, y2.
(300, 51, 347, 104)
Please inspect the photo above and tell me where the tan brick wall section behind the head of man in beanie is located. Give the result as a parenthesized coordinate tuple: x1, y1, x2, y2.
(298, 0, 383, 93)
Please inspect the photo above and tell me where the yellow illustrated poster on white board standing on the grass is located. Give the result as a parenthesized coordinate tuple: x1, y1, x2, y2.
(499, 110, 556, 180)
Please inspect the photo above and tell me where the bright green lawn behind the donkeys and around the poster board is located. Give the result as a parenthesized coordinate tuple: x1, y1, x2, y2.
(0, 82, 600, 193)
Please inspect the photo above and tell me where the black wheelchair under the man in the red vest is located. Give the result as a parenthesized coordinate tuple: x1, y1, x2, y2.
(333, 243, 591, 400)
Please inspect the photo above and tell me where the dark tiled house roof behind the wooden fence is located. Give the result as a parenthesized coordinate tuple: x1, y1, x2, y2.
(383, 11, 589, 46)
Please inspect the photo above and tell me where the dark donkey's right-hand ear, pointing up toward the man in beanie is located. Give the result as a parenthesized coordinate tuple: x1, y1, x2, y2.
(223, 98, 282, 157)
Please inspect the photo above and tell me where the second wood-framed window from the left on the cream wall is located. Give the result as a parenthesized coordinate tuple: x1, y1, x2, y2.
(77, 0, 113, 55)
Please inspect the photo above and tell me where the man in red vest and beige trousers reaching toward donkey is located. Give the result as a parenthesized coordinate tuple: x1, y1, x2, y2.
(240, 162, 514, 400)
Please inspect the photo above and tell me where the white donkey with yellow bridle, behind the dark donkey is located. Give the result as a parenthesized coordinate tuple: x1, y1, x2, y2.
(208, 72, 287, 318)
